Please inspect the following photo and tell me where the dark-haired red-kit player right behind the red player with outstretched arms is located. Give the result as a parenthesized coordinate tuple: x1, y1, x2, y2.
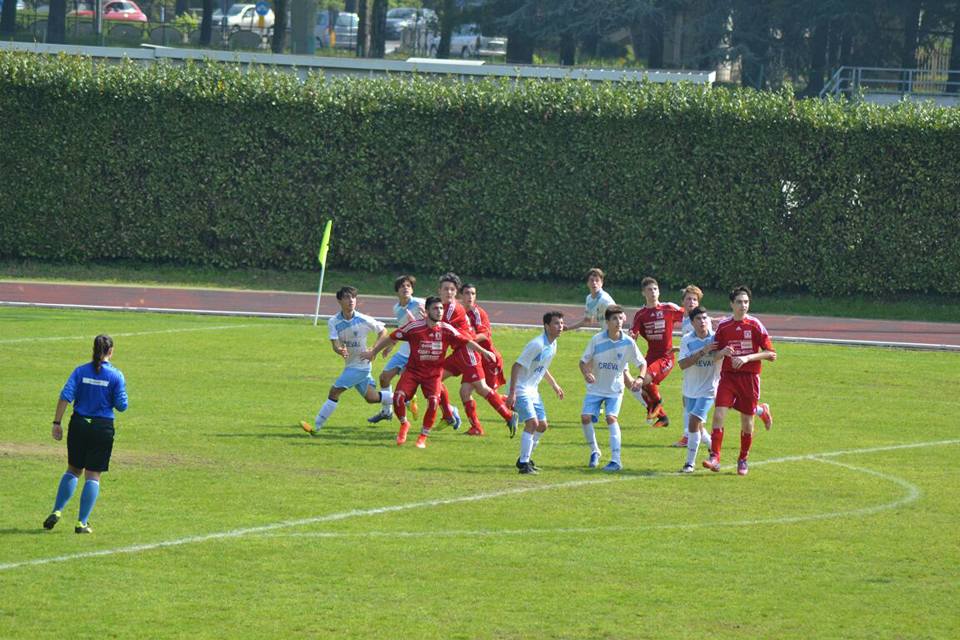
(439, 273, 519, 438)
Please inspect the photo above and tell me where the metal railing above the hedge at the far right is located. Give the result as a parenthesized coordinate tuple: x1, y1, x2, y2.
(820, 67, 960, 98)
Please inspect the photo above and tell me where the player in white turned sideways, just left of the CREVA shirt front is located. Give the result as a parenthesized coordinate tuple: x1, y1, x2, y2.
(507, 311, 563, 474)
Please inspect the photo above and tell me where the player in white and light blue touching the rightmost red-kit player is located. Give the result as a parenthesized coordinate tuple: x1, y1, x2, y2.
(678, 306, 731, 473)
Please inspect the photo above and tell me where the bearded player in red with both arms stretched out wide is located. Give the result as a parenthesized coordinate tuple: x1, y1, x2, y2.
(363, 296, 496, 449)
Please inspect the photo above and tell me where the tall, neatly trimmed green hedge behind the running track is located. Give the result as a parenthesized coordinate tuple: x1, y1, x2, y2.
(0, 53, 960, 294)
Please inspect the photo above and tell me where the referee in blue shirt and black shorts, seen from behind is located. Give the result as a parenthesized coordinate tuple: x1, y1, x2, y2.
(43, 335, 127, 533)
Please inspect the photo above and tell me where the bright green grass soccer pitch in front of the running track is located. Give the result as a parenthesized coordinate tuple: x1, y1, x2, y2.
(0, 308, 960, 639)
